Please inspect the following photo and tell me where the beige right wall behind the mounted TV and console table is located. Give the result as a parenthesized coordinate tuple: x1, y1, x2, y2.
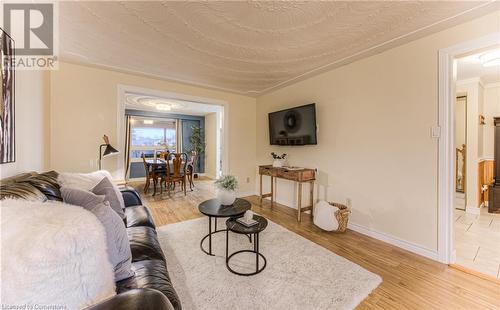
(257, 12, 500, 251)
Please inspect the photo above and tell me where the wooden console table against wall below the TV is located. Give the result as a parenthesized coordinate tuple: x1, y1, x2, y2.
(259, 165, 316, 222)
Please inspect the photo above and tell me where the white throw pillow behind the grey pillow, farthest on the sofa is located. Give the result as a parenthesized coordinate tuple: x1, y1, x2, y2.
(57, 170, 125, 210)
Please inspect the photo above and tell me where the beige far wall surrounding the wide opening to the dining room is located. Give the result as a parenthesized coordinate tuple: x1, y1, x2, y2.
(50, 63, 256, 191)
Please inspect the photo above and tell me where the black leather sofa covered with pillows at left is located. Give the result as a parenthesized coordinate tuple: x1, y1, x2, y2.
(0, 171, 182, 310)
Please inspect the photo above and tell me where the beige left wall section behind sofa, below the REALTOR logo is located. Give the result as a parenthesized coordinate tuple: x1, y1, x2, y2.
(0, 70, 50, 178)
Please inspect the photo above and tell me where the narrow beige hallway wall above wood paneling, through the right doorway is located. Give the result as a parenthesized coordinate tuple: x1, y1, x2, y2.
(483, 83, 500, 159)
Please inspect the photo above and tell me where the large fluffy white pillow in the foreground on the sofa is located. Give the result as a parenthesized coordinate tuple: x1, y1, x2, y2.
(0, 199, 116, 309)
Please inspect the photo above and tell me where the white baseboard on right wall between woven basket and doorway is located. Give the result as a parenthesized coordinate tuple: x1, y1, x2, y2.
(347, 223, 439, 261)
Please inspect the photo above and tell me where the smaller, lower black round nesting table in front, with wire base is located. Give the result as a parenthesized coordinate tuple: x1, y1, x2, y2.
(226, 215, 267, 276)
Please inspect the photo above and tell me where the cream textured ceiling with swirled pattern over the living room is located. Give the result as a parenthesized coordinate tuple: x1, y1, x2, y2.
(59, 1, 492, 96)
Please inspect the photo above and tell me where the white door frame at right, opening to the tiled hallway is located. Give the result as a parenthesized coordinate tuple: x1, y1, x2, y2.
(438, 32, 500, 264)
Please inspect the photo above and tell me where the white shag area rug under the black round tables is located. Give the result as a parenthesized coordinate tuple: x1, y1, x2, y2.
(158, 218, 382, 310)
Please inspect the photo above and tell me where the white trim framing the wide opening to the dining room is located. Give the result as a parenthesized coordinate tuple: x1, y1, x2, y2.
(113, 84, 229, 180)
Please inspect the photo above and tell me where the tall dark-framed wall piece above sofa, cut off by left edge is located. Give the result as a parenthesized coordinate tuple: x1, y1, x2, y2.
(0, 28, 16, 164)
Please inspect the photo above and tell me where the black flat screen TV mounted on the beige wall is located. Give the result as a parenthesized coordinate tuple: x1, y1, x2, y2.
(269, 103, 317, 145)
